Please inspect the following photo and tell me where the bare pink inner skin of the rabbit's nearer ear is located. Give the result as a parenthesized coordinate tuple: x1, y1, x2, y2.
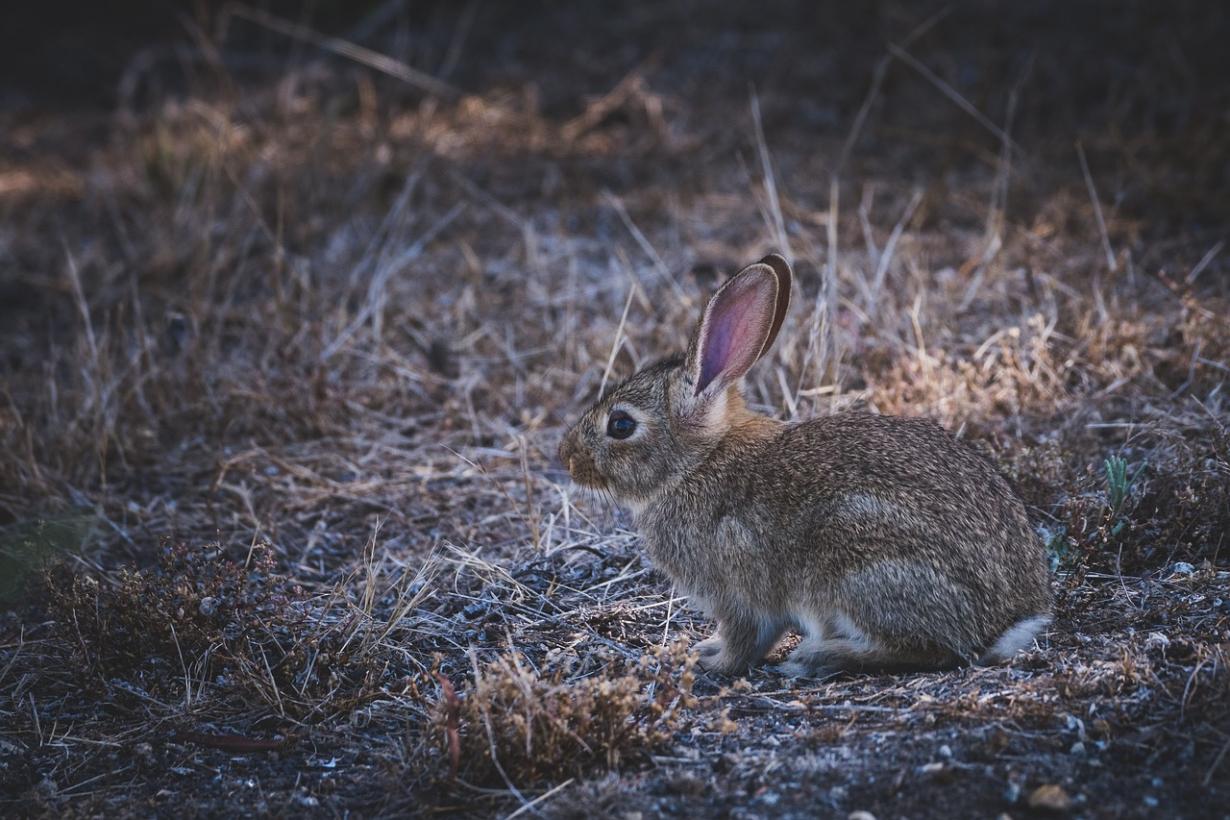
(696, 278, 774, 393)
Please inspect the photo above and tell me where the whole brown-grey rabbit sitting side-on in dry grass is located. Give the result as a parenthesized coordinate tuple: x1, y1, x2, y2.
(558, 254, 1050, 677)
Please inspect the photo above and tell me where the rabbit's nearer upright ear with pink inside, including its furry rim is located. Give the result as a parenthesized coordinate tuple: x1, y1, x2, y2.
(688, 259, 790, 396)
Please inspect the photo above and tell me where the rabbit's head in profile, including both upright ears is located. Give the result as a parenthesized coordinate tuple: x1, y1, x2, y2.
(560, 254, 792, 507)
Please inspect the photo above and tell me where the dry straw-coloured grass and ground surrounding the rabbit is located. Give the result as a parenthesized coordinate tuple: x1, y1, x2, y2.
(0, 2, 1230, 818)
